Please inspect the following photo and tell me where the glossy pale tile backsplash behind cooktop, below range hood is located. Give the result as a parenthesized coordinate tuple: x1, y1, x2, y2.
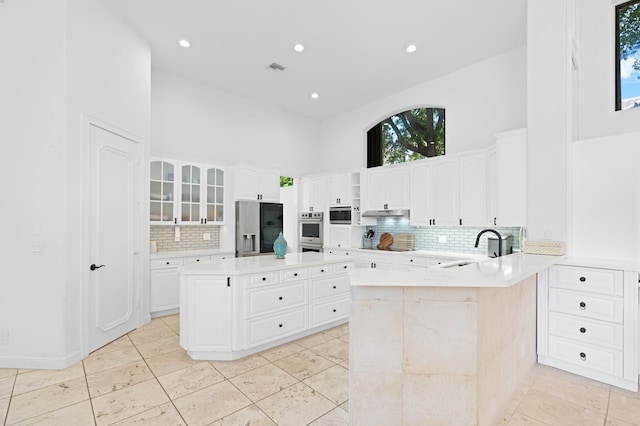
(367, 217, 521, 254)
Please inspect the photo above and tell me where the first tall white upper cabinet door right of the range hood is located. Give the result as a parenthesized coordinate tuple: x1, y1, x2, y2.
(410, 161, 433, 226)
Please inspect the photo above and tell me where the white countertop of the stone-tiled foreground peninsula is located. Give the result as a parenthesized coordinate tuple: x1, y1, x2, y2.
(351, 253, 564, 287)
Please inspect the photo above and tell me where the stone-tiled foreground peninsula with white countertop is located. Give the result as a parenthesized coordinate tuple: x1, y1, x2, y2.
(349, 254, 561, 426)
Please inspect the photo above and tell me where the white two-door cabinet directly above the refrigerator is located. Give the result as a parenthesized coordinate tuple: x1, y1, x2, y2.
(234, 166, 280, 203)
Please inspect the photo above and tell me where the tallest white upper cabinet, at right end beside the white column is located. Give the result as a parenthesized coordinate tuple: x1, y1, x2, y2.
(487, 129, 527, 226)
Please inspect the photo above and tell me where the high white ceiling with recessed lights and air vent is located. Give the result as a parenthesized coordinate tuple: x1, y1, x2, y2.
(104, 0, 526, 120)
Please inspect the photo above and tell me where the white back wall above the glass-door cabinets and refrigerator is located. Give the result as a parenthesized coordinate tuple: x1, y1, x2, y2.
(151, 70, 319, 176)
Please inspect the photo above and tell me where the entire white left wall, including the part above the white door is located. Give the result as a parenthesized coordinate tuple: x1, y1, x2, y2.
(0, 0, 150, 368)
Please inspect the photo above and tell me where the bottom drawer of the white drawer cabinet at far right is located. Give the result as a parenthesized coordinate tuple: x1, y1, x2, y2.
(549, 336, 622, 376)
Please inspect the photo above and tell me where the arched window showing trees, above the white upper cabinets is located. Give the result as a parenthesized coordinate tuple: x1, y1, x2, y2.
(367, 108, 445, 167)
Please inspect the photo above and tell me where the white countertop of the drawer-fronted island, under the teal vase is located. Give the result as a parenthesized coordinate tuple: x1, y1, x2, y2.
(179, 252, 353, 275)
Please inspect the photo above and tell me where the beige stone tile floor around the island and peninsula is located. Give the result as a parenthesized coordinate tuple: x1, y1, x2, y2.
(0, 315, 640, 426)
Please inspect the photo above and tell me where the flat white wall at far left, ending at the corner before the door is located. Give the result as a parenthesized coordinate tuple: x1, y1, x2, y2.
(0, 0, 67, 367)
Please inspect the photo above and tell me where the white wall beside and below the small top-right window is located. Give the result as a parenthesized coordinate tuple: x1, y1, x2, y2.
(577, 0, 640, 139)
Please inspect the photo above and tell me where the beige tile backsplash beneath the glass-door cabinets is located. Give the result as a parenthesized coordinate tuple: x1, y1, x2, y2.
(149, 225, 220, 253)
